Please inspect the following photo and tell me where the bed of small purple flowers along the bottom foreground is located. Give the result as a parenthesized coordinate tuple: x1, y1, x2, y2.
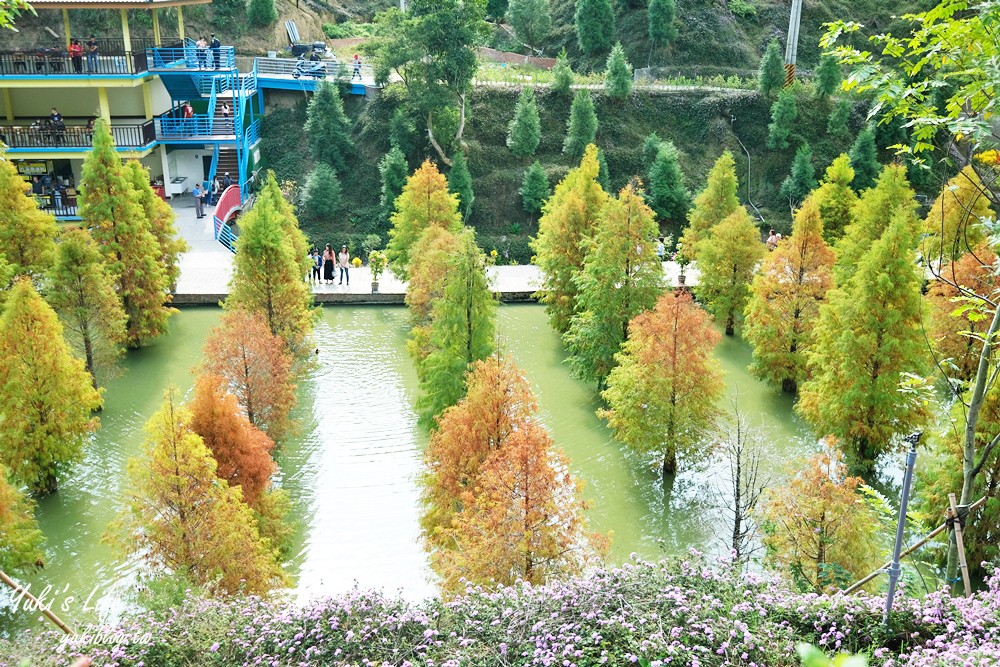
(0, 558, 1000, 667)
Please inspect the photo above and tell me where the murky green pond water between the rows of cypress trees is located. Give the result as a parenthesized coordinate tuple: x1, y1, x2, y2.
(0, 305, 815, 631)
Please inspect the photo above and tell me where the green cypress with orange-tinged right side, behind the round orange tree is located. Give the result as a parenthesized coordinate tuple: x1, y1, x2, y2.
(563, 185, 663, 388)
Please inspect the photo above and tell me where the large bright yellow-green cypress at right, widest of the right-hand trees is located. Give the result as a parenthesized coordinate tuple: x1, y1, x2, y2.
(797, 214, 927, 465)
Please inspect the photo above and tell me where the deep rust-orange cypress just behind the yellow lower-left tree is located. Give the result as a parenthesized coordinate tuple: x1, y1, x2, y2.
(189, 375, 277, 506)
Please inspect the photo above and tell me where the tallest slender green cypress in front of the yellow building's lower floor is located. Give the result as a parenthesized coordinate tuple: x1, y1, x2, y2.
(79, 119, 176, 348)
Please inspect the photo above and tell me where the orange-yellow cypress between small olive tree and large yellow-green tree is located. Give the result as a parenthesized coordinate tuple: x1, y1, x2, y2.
(743, 201, 834, 392)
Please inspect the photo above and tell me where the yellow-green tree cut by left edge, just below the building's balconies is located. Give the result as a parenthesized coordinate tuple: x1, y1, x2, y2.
(0, 143, 56, 278)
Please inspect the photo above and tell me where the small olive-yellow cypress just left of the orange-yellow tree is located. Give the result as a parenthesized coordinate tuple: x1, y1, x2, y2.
(695, 206, 766, 336)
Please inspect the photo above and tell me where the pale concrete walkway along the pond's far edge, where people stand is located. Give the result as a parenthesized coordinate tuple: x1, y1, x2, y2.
(173, 196, 697, 306)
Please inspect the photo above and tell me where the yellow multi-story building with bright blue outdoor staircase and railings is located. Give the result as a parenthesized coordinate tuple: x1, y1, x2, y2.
(0, 0, 263, 219)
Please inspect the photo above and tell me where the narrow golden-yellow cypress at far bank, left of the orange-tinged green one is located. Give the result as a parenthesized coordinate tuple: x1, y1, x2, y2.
(531, 144, 608, 333)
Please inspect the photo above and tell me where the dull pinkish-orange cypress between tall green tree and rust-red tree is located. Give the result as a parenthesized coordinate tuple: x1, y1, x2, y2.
(203, 310, 295, 441)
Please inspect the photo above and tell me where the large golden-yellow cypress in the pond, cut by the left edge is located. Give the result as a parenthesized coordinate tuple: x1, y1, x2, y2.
(0, 278, 101, 495)
